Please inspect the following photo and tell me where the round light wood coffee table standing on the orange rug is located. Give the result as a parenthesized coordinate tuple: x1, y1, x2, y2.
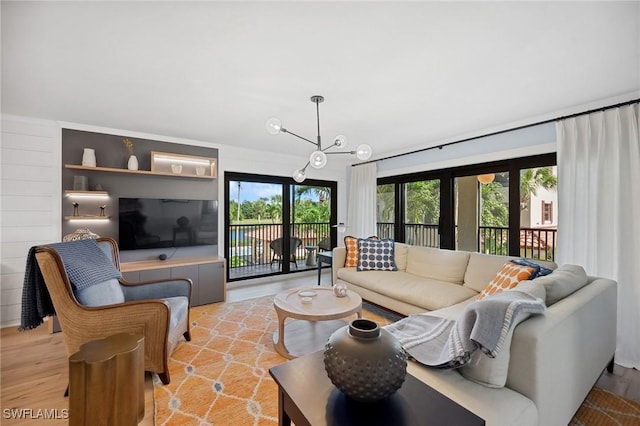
(273, 287, 362, 359)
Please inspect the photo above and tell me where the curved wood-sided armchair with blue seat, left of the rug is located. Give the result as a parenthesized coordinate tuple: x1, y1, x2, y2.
(35, 238, 192, 384)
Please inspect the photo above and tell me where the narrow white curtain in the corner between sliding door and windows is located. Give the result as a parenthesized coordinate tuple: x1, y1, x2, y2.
(346, 162, 377, 238)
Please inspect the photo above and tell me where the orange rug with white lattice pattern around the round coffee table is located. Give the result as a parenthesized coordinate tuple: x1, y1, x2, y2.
(153, 296, 394, 426)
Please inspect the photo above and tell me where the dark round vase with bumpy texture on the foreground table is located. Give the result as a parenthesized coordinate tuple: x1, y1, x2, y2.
(324, 319, 407, 402)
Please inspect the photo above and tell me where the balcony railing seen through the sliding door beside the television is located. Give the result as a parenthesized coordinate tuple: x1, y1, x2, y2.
(229, 223, 331, 268)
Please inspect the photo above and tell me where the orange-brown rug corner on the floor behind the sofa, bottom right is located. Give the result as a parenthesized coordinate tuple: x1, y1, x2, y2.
(569, 388, 640, 426)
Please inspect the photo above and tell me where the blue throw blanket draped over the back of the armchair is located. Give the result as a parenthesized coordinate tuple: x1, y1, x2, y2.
(19, 239, 122, 331)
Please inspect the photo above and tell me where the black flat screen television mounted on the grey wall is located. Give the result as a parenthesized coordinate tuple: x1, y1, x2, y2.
(118, 198, 218, 250)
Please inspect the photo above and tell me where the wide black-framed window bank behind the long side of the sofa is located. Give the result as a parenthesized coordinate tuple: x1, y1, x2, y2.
(378, 154, 557, 260)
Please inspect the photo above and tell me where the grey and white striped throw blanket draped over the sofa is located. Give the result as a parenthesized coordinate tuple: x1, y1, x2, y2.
(385, 290, 545, 368)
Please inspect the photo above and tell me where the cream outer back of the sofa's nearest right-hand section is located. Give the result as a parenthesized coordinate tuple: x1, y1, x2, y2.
(507, 277, 617, 424)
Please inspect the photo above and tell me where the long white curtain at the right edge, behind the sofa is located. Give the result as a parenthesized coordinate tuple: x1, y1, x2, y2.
(556, 103, 640, 369)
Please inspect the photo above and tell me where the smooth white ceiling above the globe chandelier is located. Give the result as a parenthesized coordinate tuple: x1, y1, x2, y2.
(1, 1, 640, 163)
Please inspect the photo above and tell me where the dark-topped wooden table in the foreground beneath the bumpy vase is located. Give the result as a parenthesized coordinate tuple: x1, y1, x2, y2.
(269, 351, 485, 426)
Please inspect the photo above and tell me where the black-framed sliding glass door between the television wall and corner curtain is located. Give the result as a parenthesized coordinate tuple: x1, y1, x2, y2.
(225, 173, 337, 281)
